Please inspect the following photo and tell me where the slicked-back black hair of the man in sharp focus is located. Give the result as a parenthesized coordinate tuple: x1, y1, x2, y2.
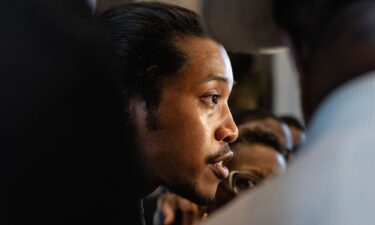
(102, 2, 207, 127)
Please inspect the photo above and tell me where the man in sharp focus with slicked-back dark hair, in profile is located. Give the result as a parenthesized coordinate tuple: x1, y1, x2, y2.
(102, 3, 237, 224)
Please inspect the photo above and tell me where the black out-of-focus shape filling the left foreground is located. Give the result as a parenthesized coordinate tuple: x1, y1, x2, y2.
(0, 0, 144, 225)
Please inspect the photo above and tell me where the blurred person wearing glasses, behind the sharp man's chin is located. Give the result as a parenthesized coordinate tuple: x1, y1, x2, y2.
(206, 125, 286, 213)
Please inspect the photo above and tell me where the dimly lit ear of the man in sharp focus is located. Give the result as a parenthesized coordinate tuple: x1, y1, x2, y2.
(129, 97, 147, 128)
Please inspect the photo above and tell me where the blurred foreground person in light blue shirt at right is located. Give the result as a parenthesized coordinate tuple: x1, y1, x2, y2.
(203, 0, 375, 225)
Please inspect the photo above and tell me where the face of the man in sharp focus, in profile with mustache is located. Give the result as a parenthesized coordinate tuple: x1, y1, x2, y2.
(131, 37, 238, 204)
